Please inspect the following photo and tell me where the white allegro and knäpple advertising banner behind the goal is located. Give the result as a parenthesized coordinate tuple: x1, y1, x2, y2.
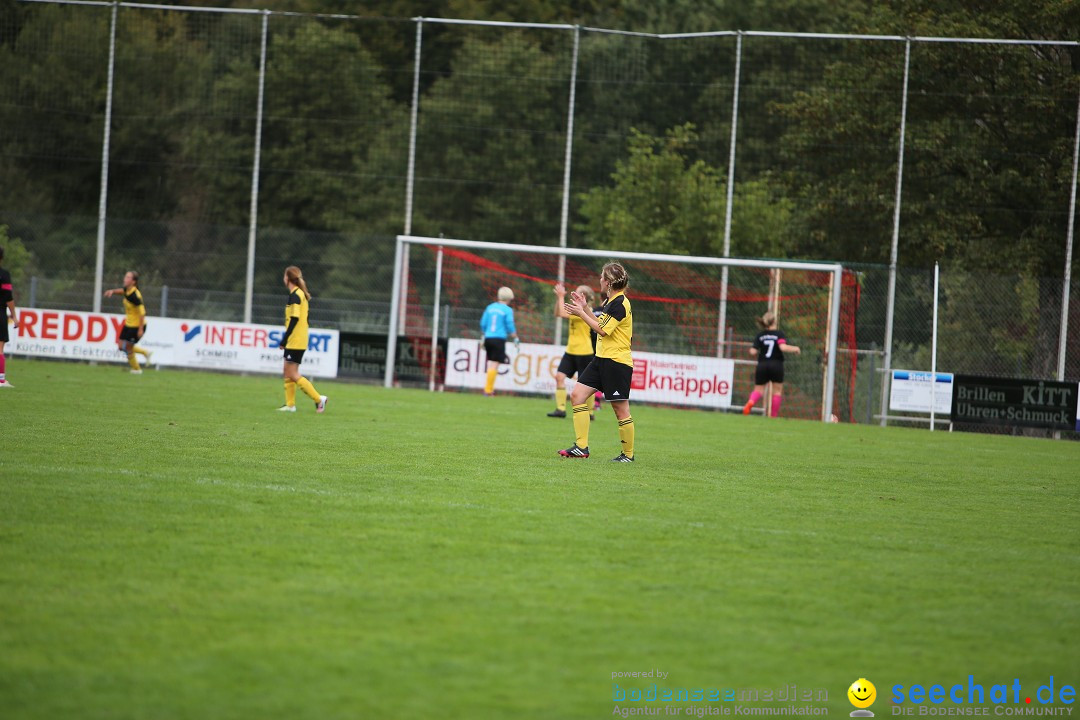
(446, 338, 734, 408)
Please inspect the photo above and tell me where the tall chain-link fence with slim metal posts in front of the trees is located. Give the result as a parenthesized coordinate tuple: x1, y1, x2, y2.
(0, 2, 1080, 422)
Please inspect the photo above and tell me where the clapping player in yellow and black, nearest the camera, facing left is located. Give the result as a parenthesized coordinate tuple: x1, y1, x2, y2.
(558, 262, 634, 462)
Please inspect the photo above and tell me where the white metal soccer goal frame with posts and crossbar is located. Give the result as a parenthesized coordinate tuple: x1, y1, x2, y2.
(383, 235, 843, 422)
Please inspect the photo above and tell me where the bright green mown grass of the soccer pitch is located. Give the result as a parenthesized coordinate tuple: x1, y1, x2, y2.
(0, 358, 1080, 720)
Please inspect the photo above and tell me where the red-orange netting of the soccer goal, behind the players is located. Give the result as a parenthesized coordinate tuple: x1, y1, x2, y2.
(386, 235, 859, 421)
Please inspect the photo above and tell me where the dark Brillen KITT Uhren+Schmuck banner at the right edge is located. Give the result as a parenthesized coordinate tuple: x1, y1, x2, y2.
(949, 375, 1080, 430)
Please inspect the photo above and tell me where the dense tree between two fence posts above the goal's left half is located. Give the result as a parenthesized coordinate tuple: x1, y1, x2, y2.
(406, 30, 569, 245)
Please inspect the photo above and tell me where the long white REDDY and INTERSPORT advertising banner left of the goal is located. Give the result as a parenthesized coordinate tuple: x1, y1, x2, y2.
(6, 308, 340, 378)
